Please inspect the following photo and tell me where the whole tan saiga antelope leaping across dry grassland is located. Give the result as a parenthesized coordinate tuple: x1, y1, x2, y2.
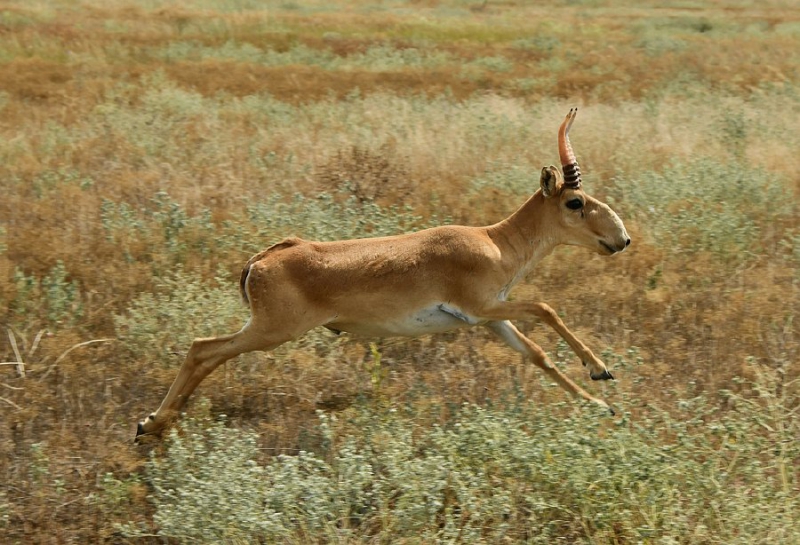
(136, 109, 631, 436)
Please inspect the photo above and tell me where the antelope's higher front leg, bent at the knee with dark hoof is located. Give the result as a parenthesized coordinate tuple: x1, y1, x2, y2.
(480, 301, 614, 380)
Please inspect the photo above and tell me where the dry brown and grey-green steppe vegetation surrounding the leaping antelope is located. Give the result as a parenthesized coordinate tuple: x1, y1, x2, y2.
(0, 0, 800, 544)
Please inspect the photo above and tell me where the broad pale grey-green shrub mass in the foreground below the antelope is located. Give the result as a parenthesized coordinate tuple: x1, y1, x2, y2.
(124, 364, 800, 543)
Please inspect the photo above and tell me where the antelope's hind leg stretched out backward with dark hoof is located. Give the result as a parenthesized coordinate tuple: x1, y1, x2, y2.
(136, 322, 294, 437)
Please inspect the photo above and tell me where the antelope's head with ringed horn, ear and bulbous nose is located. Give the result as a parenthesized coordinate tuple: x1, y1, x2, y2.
(540, 108, 631, 255)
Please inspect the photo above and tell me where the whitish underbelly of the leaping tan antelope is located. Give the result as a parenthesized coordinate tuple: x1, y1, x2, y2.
(326, 304, 478, 337)
